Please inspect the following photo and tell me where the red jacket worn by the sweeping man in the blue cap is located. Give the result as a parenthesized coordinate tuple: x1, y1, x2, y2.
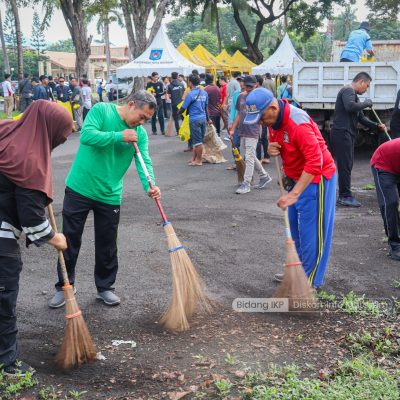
(270, 100, 336, 183)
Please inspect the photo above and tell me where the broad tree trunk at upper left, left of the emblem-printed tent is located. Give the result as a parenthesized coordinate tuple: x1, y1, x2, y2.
(60, 0, 92, 78)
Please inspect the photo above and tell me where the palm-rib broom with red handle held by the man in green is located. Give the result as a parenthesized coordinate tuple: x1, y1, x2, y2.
(132, 143, 211, 332)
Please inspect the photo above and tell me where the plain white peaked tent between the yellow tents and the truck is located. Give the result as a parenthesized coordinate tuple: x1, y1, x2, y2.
(252, 33, 304, 75)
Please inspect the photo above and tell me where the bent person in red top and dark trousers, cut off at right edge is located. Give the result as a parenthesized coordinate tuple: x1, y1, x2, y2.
(371, 138, 400, 261)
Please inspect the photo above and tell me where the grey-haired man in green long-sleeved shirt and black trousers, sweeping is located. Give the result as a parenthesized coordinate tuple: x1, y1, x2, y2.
(49, 90, 161, 308)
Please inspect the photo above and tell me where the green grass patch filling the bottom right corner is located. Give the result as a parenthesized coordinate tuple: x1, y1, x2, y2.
(203, 356, 400, 400)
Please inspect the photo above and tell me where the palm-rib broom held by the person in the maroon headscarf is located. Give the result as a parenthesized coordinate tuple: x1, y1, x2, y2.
(47, 204, 96, 369)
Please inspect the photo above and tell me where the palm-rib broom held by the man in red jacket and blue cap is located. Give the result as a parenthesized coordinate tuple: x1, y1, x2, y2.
(274, 157, 316, 311)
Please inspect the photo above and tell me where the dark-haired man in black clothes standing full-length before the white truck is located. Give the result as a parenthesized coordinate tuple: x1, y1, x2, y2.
(331, 72, 385, 207)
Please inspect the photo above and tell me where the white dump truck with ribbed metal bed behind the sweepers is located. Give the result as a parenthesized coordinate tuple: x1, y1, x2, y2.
(293, 61, 400, 146)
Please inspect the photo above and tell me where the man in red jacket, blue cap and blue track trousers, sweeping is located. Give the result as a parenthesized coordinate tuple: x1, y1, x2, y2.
(244, 88, 336, 287)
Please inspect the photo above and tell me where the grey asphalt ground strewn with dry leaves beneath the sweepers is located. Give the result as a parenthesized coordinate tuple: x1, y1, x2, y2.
(4, 130, 400, 400)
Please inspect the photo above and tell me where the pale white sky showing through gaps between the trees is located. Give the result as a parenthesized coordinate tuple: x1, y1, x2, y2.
(0, 0, 368, 46)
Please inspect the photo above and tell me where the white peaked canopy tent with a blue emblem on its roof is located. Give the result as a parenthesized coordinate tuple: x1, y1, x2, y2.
(117, 25, 205, 79)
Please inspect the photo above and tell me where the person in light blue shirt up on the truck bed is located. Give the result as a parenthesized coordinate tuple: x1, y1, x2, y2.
(340, 21, 374, 62)
